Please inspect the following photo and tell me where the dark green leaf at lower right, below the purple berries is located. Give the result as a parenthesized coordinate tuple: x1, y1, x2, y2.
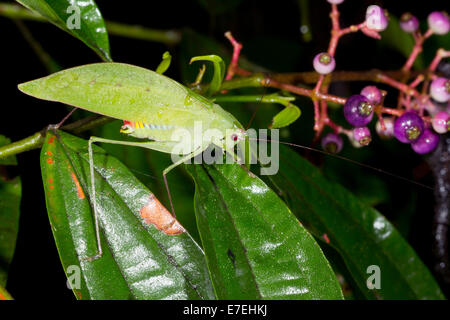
(269, 146, 444, 299)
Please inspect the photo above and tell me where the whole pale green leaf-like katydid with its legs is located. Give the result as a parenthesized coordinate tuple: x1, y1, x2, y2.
(19, 63, 250, 259)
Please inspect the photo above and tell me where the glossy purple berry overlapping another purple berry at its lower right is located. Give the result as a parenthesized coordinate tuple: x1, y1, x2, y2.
(394, 111, 425, 143)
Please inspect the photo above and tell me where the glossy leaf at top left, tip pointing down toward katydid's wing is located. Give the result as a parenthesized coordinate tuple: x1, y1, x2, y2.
(17, 0, 112, 61)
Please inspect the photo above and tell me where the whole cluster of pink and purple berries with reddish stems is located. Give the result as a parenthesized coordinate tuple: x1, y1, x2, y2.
(313, 0, 450, 154)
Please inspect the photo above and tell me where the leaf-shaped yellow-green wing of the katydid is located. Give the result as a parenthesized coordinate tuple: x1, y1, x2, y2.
(19, 63, 218, 125)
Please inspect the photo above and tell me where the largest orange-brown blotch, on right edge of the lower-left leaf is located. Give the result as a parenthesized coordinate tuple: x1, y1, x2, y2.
(139, 194, 186, 235)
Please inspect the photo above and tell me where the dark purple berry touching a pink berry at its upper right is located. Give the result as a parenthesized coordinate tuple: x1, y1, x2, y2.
(344, 94, 373, 127)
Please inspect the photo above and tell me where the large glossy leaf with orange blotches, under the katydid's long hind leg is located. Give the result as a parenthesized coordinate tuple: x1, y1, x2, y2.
(41, 132, 215, 299)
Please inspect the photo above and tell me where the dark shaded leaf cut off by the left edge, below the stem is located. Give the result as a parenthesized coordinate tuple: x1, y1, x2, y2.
(0, 135, 22, 286)
